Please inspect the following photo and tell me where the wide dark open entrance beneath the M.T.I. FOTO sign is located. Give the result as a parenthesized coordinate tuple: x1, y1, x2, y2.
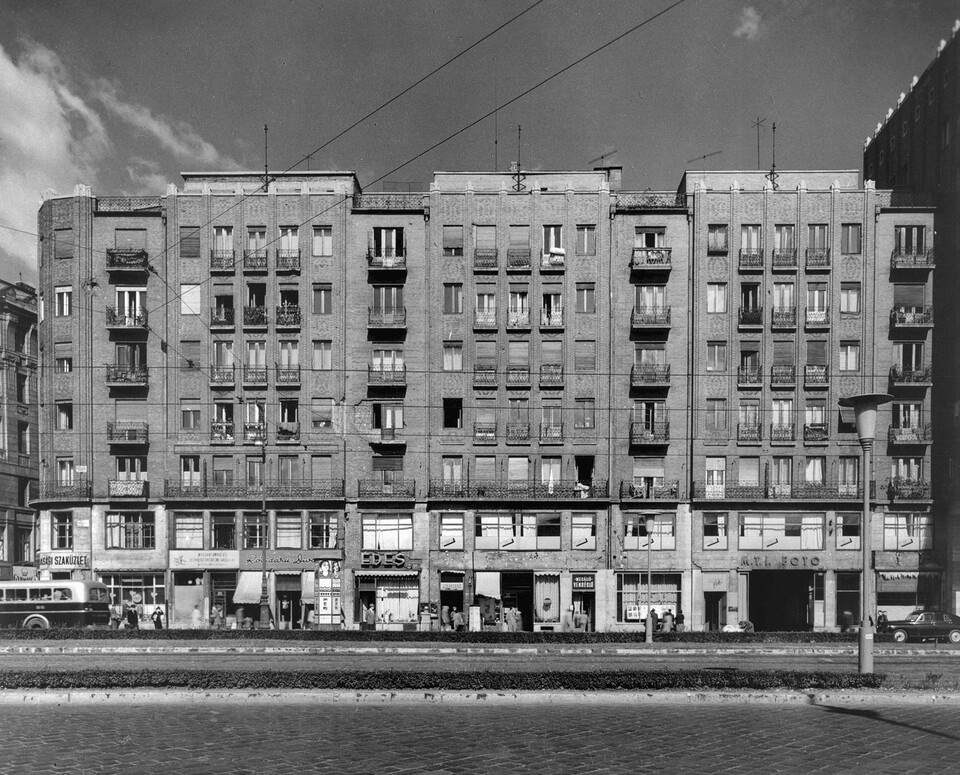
(749, 570, 815, 632)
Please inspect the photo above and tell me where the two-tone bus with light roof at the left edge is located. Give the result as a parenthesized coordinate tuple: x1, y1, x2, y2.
(0, 581, 110, 630)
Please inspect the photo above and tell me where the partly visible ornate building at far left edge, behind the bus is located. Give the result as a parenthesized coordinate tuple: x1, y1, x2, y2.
(0, 280, 40, 579)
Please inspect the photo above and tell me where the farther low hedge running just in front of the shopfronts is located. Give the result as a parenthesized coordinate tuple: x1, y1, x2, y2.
(0, 628, 892, 645)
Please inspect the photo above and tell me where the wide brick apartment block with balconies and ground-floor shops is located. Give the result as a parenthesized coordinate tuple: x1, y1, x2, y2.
(38, 168, 929, 630)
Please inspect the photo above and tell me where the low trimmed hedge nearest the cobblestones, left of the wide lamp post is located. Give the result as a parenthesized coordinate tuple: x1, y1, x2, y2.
(0, 670, 886, 692)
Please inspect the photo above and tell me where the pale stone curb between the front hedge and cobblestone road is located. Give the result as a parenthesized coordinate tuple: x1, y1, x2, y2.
(0, 689, 960, 707)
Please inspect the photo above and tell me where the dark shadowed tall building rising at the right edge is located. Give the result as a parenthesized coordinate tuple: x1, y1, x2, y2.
(863, 20, 960, 611)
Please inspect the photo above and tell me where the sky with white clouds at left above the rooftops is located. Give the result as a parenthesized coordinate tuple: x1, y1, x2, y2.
(0, 0, 960, 283)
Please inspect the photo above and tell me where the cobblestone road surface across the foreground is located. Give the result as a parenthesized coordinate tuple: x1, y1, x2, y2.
(0, 700, 960, 775)
